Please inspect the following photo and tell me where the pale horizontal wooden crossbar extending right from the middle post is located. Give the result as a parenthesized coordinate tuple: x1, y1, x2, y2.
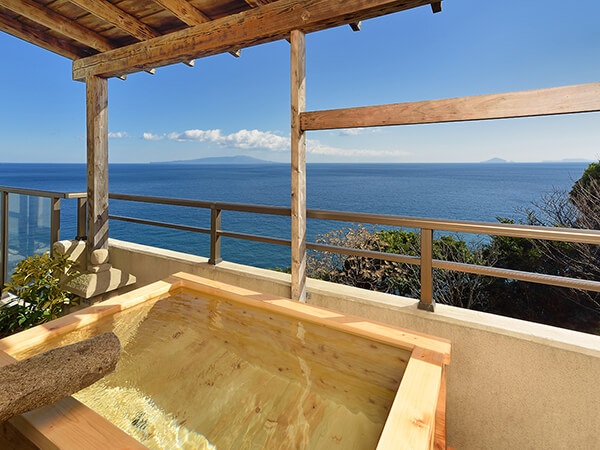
(300, 83, 600, 131)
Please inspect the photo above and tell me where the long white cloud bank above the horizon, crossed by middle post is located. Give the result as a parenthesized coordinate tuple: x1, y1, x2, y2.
(143, 128, 409, 157)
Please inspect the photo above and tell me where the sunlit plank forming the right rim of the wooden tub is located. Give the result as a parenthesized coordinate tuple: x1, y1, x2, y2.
(377, 347, 442, 450)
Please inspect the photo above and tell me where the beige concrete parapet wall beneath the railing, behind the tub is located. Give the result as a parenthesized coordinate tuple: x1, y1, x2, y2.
(110, 240, 600, 449)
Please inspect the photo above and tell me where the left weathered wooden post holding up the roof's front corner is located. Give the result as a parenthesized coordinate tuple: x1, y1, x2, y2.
(86, 76, 108, 261)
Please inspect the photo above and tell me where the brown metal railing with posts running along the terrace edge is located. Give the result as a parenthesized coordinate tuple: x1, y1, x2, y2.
(0, 187, 600, 311)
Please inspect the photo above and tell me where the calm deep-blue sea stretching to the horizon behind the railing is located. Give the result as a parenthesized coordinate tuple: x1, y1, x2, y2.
(0, 163, 587, 268)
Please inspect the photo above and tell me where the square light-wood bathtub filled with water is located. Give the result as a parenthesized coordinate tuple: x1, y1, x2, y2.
(0, 273, 450, 449)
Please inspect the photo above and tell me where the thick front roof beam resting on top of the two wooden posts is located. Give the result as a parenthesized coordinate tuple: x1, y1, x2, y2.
(74, 0, 431, 80)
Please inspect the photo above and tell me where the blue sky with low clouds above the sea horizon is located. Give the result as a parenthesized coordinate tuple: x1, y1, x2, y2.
(0, 0, 600, 163)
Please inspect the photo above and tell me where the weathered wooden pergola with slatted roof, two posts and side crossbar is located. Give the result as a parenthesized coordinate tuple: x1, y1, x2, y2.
(0, 0, 600, 308)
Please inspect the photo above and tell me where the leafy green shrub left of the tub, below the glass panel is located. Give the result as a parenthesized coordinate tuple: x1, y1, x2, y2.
(0, 253, 78, 337)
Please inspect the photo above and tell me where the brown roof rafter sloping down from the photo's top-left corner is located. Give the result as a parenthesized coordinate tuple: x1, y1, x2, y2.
(0, 0, 117, 52)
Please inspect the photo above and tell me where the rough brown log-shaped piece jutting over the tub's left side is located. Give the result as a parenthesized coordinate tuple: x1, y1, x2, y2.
(0, 332, 121, 422)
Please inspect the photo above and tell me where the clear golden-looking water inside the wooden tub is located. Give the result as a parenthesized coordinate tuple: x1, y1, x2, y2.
(16, 292, 409, 449)
